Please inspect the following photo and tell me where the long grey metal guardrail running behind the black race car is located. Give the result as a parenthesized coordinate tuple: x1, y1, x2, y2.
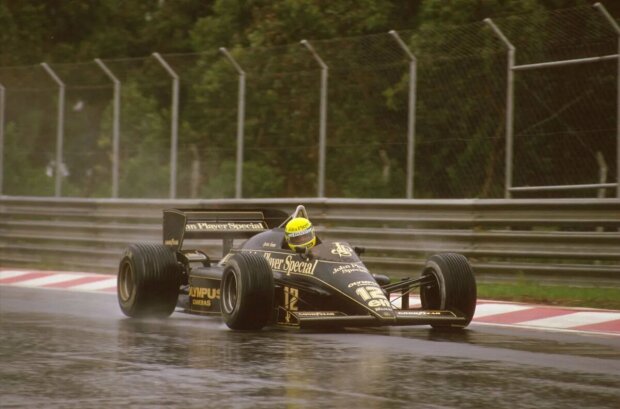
(0, 196, 620, 285)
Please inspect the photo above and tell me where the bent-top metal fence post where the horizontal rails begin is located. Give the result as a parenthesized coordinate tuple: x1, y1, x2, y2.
(484, 18, 516, 199)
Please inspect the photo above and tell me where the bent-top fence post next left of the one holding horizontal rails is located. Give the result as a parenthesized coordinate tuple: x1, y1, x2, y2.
(389, 30, 417, 199)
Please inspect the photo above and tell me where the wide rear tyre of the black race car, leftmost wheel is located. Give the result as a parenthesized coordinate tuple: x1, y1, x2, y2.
(116, 243, 181, 318)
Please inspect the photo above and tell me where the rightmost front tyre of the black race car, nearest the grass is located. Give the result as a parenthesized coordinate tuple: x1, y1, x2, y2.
(420, 253, 477, 328)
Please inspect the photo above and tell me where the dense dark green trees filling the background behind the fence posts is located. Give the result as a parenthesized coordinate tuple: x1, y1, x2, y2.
(0, 0, 618, 198)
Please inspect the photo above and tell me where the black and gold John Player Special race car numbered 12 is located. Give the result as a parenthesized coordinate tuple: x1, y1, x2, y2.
(117, 206, 476, 330)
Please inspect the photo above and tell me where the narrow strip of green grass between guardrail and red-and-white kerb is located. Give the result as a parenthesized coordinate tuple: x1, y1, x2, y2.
(478, 280, 620, 310)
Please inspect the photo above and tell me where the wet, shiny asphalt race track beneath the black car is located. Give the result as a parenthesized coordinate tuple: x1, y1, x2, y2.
(0, 287, 620, 408)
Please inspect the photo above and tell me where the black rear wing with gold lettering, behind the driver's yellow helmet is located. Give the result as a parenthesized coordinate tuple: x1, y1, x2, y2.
(163, 209, 288, 251)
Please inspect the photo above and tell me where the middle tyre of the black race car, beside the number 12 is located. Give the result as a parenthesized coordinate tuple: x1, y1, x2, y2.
(220, 253, 274, 330)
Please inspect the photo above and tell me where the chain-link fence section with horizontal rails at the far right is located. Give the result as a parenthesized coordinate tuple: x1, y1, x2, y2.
(497, 7, 620, 197)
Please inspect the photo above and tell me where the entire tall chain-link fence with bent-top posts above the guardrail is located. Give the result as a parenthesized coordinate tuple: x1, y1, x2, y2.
(0, 3, 620, 198)
